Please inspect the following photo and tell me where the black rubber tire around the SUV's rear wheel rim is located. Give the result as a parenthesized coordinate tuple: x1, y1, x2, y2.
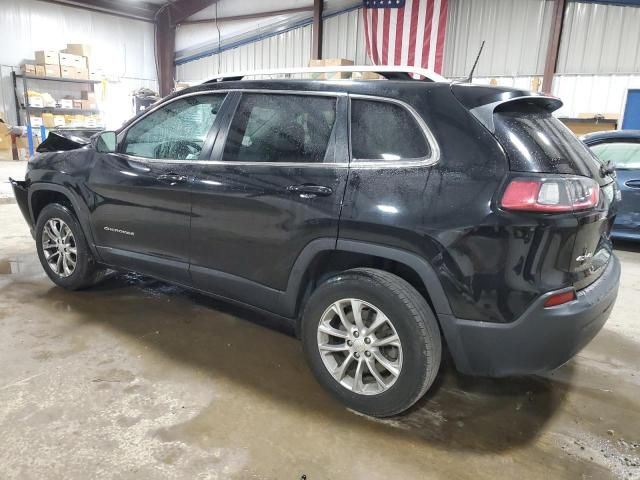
(301, 268, 442, 417)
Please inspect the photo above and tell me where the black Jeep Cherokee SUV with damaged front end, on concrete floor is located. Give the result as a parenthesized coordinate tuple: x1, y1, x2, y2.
(13, 67, 620, 416)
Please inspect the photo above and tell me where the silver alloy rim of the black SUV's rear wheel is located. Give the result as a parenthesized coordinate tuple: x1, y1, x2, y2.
(317, 298, 402, 395)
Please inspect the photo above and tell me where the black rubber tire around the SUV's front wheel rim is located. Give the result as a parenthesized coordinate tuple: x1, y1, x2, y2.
(35, 203, 105, 290)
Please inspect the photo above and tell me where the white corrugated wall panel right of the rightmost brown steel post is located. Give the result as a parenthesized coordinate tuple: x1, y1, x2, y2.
(558, 2, 640, 74)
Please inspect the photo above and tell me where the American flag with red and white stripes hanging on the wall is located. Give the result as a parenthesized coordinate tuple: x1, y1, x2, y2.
(362, 0, 447, 73)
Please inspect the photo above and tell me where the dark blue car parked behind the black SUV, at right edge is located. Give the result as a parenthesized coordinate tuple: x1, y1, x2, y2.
(582, 130, 640, 240)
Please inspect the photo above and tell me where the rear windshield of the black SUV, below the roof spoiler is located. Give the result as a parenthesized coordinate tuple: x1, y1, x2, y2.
(494, 103, 600, 178)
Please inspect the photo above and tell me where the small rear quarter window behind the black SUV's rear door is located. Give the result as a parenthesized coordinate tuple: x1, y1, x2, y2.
(351, 99, 431, 161)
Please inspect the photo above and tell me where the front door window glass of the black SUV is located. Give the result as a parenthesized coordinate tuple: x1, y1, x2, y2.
(123, 94, 224, 160)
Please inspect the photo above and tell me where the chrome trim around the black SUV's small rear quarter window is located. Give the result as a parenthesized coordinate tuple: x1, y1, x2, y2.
(349, 93, 440, 168)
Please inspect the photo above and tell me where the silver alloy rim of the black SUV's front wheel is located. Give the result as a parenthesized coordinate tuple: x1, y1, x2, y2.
(42, 218, 78, 278)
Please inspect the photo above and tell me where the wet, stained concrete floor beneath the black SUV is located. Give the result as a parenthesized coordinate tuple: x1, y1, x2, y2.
(0, 165, 640, 480)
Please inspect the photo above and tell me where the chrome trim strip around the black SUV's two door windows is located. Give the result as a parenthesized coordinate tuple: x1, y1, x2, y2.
(118, 88, 349, 168)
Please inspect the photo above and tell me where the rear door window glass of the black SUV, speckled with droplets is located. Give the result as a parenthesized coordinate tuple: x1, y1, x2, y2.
(223, 93, 336, 163)
